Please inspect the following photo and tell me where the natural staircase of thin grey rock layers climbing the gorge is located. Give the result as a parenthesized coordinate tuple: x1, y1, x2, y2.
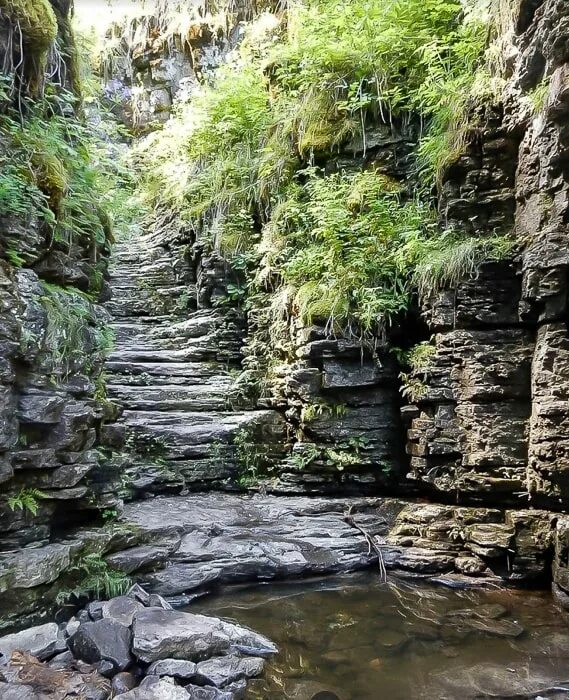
(103, 238, 285, 500)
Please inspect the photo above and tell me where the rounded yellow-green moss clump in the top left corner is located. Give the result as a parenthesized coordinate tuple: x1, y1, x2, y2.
(0, 0, 57, 54)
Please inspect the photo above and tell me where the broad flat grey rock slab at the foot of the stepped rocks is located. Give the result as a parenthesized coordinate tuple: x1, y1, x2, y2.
(118, 493, 404, 595)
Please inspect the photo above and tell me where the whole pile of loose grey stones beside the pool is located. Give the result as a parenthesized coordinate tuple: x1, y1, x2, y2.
(0, 586, 277, 700)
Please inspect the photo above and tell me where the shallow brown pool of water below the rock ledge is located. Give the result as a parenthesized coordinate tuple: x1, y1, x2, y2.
(189, 573, 569, 700)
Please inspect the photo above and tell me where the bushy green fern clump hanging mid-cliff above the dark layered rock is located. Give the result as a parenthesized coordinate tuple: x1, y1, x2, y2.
(274, 169, 432, 334)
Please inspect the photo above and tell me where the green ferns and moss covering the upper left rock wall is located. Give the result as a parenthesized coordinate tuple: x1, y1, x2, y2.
(0, 92, 116, 254)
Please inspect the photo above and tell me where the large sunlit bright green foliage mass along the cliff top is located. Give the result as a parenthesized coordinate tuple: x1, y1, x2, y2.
(139, 0, 487, 246)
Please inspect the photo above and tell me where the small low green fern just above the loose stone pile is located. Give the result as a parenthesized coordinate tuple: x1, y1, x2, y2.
(57, 553, 131, 603)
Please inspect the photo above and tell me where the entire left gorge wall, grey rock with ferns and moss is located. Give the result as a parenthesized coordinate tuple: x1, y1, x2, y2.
(0, 0, 119, 624)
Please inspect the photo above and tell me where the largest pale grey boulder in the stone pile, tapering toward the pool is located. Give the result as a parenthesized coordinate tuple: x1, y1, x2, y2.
(132, 608, 277, 663)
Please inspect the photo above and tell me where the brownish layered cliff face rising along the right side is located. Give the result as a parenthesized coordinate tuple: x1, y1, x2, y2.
(405, 1, 569, 509)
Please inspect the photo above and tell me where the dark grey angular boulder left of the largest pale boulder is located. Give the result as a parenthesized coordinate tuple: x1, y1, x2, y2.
(69, 618, 132, 675)
